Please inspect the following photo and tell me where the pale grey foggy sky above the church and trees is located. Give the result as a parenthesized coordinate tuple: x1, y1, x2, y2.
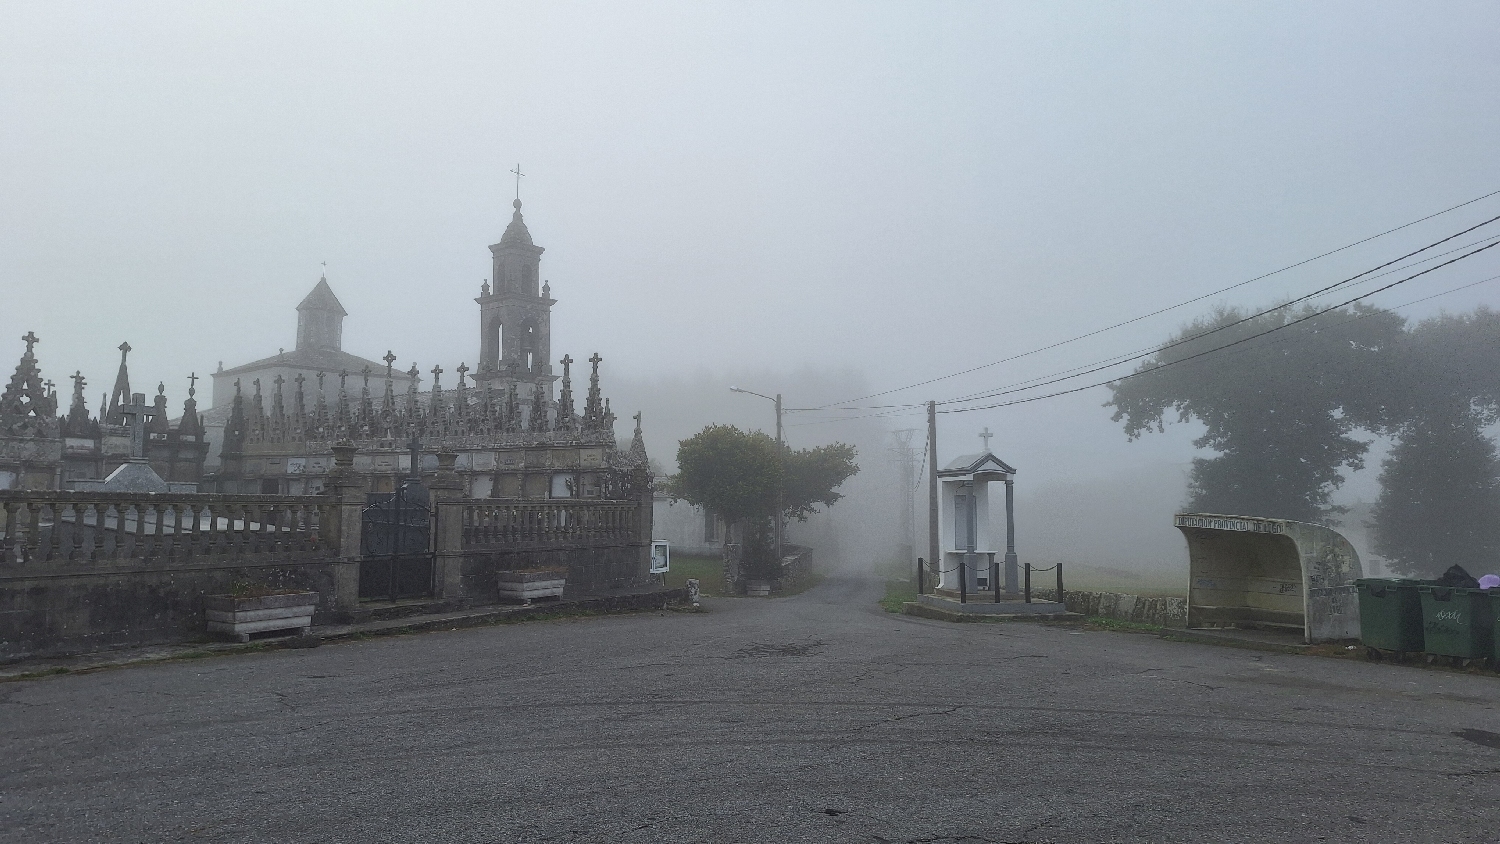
(0, 1, 1500, 587)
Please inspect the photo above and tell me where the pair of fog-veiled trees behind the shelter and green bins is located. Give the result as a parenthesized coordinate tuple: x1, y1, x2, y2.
(1106, 304, 1500, 576)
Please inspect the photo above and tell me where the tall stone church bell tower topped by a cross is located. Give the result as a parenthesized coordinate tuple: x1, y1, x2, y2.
(474, 199, 557, 400)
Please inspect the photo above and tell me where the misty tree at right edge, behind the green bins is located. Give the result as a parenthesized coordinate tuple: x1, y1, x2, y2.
(1371, 309, 1500, 577)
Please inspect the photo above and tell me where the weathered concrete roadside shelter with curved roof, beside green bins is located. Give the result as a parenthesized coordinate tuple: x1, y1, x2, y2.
(1175, 513, 1362, 643)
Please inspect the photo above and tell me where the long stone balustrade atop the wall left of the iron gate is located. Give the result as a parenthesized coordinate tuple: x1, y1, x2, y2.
(0, 490, 336, 567)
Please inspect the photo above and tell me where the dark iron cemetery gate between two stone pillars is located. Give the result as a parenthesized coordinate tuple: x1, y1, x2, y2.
(360, 480, 432, 601)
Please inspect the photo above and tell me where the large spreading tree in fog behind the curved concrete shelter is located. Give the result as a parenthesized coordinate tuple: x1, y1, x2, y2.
(1106, 306, 1404, 522)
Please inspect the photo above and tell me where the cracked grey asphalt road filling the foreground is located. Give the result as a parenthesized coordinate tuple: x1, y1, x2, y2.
(0, 579, 1500, 844)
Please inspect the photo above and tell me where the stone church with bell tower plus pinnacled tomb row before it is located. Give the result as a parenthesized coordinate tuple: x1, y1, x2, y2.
(213, 199, 650, 501)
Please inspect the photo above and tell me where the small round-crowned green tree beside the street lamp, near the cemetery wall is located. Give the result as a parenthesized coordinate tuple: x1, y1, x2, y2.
(666, 424, 860, 581)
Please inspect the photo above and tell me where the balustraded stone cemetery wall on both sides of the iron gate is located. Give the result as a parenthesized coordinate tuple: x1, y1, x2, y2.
(0, 476, 651, 661)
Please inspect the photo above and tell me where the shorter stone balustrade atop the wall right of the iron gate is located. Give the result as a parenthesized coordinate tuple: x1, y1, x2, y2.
(462, 499, 639, 550)
